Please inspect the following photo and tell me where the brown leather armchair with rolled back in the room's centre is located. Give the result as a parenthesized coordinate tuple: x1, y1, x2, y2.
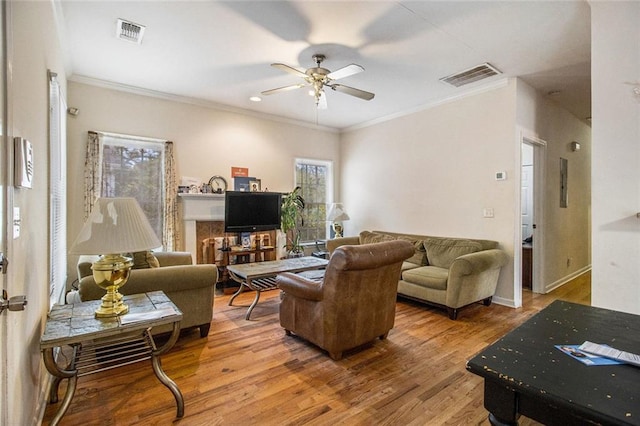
(277, 240, 414, 360)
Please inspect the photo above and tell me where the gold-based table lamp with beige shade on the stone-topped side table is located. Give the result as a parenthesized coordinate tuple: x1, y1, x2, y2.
(69, 198, 162, 318)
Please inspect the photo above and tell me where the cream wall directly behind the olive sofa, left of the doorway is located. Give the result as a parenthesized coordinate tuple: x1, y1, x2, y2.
(341, 81, 520, 303)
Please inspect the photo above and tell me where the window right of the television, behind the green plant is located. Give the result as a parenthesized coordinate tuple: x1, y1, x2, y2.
(295, 158, 333, 242)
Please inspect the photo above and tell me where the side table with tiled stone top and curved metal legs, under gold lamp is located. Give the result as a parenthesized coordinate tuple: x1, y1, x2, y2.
(40, 291, 184, 425)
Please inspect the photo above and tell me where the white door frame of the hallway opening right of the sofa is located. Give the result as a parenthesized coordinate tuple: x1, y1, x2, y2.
(514, 129, 547, 306)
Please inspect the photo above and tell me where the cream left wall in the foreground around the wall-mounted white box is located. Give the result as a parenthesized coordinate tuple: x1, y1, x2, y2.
(1, 1, 66, 425)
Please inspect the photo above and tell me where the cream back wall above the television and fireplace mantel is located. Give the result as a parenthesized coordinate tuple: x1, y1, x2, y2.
(67, 81, 340, 279)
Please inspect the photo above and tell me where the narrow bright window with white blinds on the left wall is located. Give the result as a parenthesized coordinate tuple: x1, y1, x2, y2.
(49, 72, 67, 307)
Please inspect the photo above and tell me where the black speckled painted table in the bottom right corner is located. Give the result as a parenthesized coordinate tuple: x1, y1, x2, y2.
(467, 301, 640, 426)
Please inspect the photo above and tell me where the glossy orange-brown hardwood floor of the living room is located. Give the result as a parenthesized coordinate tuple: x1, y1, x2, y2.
(43, 273, 591, 426)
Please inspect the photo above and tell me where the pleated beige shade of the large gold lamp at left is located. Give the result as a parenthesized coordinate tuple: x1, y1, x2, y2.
(69, 198, 162, 254)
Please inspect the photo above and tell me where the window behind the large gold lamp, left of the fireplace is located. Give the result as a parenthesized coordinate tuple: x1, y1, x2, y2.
(100, 134, 164, 237)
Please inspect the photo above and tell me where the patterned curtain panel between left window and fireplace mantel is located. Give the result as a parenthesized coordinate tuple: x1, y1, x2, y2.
(162, 141, 180, 251)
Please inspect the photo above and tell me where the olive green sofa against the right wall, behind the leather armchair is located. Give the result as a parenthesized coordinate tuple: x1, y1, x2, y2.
(327, 231, 509, 320)
